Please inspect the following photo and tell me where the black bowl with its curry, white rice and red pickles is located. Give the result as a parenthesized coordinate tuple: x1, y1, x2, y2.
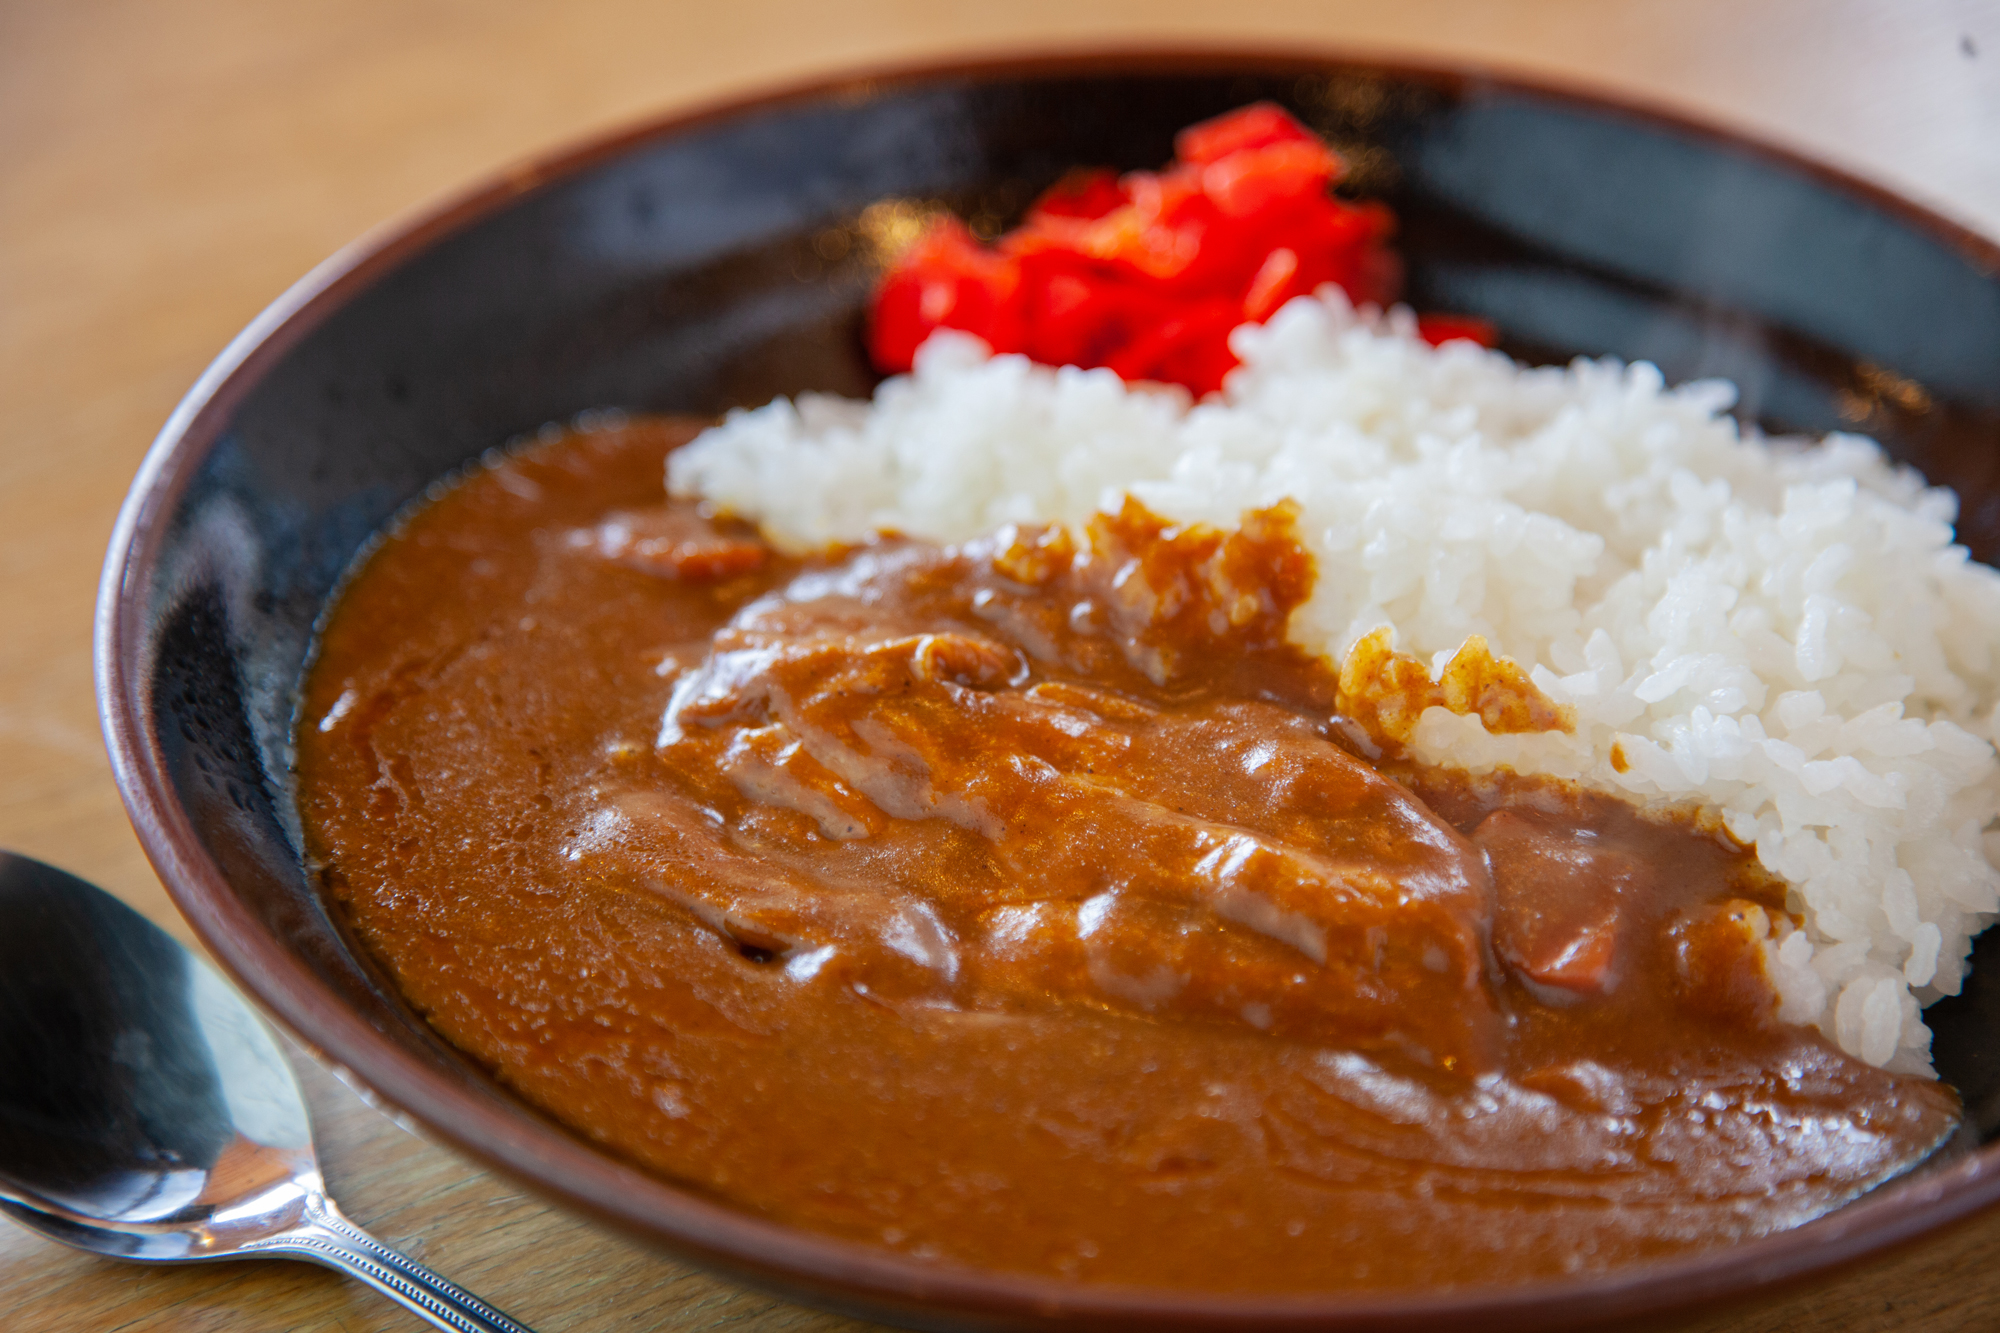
(98, 52, 2000, 1329)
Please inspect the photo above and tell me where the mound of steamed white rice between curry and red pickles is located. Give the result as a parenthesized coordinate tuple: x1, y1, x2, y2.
(668, 292, 2000, 1071)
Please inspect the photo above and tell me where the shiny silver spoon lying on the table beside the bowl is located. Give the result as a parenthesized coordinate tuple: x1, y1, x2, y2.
(0, 853, 530, 1333)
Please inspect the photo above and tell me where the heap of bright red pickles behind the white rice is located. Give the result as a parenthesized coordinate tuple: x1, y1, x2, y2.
(868, 102, 1400, 394)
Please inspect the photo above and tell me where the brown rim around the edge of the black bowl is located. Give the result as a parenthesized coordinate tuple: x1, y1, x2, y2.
(94, 44, 2000, 1329)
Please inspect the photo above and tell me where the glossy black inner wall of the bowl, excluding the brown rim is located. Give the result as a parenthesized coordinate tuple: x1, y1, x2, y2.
(100, 58, 2000, 1320)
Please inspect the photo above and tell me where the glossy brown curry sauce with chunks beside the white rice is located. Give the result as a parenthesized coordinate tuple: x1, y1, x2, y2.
(298, 422, 1958, 1291)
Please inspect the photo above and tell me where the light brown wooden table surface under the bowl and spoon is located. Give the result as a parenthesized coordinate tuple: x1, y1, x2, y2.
(11, 0, 2000, 1333)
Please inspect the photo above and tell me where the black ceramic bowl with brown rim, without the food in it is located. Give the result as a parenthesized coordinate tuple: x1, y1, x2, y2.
(96, 54, 2000, 1329)
